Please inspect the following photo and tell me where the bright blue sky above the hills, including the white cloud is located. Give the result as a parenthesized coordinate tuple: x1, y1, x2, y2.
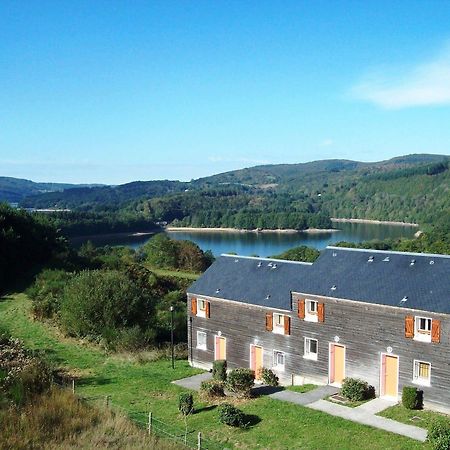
(0, 0, 450, 184)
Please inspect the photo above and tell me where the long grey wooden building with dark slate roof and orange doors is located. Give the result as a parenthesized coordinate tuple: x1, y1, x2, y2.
(188, 247, 450, 411)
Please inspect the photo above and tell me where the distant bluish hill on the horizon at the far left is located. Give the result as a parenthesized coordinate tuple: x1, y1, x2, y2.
(0, 177, 103, 203)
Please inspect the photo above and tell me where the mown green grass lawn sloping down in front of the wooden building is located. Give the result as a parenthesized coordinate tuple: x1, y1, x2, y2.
(0, 294, 430, 450)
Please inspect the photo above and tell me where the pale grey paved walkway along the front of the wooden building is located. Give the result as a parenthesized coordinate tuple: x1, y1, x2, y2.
(172, 372, 427, 442)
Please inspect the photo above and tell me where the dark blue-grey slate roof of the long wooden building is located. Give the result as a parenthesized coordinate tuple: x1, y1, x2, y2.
(188, 247, 450, 314)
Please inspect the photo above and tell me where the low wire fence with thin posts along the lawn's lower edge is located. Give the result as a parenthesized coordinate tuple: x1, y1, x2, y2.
(53, 379, 230, 450)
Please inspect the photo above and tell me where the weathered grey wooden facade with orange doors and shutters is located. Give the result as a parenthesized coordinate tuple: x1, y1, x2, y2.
(188, 292, 450, 411)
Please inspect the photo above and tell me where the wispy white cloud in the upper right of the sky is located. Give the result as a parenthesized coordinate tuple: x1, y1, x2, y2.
(351, 45, 450, 109)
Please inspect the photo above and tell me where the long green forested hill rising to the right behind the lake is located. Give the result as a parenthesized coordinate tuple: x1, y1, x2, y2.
(9, 155, 450, 234)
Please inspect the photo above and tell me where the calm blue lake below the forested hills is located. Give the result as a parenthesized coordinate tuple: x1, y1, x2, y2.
(72, 223, 418, 257)
